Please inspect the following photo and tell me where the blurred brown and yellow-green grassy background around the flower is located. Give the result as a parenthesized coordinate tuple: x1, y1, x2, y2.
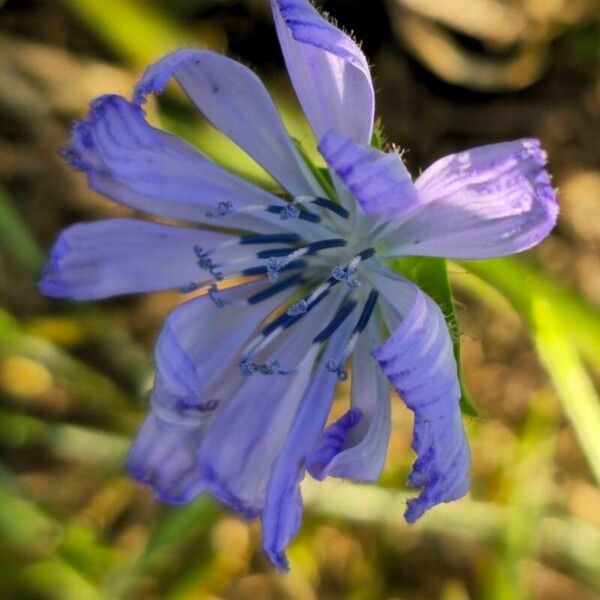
(0, 0, 600, 600)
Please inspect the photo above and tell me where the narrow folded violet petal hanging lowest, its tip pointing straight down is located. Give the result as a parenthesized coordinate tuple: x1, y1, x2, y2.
(262, 314, 352, 570)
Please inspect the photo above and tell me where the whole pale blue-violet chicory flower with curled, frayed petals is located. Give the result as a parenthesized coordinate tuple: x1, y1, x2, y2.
(40, 0, 558, 568)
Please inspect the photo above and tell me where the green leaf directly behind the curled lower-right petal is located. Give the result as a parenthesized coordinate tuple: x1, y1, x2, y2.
(390, 257, 479, 417)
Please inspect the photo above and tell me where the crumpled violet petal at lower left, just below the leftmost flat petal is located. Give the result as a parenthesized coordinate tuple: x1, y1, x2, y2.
(128, 281, 300, 504)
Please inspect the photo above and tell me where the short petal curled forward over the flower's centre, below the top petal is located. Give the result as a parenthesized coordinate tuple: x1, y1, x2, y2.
(319, 131, 418, 218)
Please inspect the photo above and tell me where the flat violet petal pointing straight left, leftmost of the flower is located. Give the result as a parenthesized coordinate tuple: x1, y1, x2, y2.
(40, 219, 232, 300)
